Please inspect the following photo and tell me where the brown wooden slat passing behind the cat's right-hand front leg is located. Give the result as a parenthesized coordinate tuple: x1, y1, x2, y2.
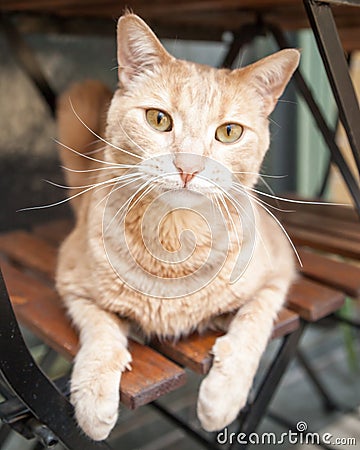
(152, 308, 299, 374)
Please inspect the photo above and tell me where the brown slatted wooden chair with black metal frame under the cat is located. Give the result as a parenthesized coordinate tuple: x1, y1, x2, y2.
(0, 199, 360, 449)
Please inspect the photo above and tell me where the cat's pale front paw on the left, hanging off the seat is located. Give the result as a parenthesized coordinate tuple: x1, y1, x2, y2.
(71, 349, 131, 441)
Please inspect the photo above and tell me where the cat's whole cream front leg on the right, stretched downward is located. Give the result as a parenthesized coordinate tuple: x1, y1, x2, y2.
(197, 280, 288, 431)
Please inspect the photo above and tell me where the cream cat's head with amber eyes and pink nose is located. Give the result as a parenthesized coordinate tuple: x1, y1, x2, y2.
(107, 14, 299, 202)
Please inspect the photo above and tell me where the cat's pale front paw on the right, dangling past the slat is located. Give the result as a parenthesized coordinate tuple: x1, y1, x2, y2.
(197, 335, 252, 431)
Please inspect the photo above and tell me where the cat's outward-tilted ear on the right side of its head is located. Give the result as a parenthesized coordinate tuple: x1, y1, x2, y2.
(243, 49, 300, 115)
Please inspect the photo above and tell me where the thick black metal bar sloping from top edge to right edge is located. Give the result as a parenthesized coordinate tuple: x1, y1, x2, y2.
(304, 0, 360, 174)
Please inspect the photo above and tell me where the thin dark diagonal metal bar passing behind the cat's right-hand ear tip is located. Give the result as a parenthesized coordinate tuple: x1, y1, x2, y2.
(267, 24, 360, 215)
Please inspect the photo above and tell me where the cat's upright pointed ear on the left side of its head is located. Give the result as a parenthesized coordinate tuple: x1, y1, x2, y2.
(117, 13, 170, 87)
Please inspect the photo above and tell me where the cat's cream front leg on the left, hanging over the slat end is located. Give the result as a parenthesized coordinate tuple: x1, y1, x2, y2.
(67, 299, 131, 440)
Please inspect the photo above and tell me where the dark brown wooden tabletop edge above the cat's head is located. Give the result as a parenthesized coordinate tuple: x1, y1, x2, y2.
(0, 0, 360, 44)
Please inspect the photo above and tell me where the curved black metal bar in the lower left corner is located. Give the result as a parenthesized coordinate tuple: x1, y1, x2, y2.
(0, 271, 110, 450)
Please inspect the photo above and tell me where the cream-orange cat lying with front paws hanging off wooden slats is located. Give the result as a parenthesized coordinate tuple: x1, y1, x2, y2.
(56, 13, 299, 440)
